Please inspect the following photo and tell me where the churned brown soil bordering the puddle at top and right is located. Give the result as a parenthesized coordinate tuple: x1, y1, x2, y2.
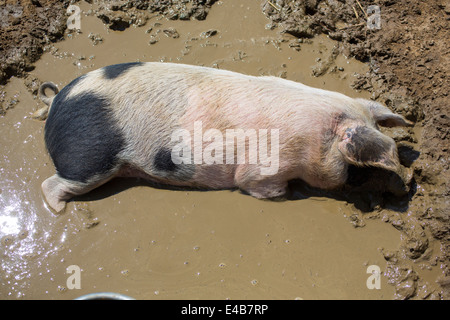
(0, 0, 450, 299)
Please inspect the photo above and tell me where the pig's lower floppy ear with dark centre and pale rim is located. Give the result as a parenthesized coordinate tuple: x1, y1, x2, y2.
(338, 126, 399, 171)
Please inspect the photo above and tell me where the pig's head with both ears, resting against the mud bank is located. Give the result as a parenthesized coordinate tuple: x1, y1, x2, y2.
(338, 99, 412, 193)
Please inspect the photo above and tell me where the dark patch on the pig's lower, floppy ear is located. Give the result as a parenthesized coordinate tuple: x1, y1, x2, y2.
(347, 126, 390, 163)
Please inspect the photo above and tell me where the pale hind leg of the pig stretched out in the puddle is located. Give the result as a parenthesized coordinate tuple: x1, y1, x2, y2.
(41, 174, 113, 213)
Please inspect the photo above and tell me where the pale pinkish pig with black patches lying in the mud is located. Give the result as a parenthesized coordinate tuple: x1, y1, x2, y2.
(39, 62, 412, 212)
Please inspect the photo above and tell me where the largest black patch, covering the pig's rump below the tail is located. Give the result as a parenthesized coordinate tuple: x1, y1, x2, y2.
(45, 85, 124, 183)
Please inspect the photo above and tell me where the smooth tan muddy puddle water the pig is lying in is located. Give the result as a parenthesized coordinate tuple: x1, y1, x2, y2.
(0, 0, 400, 299)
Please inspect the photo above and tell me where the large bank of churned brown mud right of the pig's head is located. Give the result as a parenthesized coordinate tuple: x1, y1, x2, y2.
(262, 0, 450, 299)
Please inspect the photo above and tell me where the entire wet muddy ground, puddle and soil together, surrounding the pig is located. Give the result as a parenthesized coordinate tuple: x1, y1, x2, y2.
(0, 0, 449, 299)
